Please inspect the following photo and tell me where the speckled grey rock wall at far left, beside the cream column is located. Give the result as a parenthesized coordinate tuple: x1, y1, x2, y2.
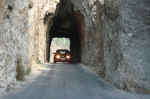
(0, 0, 29, 89)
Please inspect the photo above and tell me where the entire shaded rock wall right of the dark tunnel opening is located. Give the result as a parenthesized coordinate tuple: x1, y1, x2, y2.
(72, 0, 150, 93)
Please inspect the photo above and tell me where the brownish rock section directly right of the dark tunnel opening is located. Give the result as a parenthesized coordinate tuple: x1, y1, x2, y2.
(72, 0, 105, 73)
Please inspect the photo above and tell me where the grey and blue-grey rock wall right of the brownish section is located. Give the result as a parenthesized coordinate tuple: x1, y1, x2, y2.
(103, 0, 150, 93)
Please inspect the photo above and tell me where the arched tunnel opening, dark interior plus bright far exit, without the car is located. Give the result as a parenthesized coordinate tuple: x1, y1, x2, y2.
(46, 2, 84, 63)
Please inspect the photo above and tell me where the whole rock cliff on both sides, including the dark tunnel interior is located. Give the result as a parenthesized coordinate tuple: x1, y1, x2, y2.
(0, 0, 150, 93)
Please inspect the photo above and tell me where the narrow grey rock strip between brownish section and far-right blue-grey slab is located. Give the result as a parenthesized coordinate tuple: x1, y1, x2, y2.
(102, 0, 121, 88)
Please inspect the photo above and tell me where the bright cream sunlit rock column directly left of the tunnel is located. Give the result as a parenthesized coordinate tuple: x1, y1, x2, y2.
(29, 0, 59, 63)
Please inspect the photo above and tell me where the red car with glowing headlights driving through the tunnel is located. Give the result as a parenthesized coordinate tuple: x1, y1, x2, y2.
(54, 49, 72, 63)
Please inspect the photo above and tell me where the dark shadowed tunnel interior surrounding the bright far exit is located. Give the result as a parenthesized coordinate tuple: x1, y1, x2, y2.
(46, 2, 84, 63)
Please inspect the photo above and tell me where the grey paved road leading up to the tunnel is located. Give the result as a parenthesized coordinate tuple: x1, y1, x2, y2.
(2, 64, 150, 99)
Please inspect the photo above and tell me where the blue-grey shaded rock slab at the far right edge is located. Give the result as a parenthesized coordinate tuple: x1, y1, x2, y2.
(118, 0, 150, 93)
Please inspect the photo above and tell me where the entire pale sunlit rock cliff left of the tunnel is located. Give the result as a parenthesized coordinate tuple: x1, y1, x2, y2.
(0, 0, 58, 90)
